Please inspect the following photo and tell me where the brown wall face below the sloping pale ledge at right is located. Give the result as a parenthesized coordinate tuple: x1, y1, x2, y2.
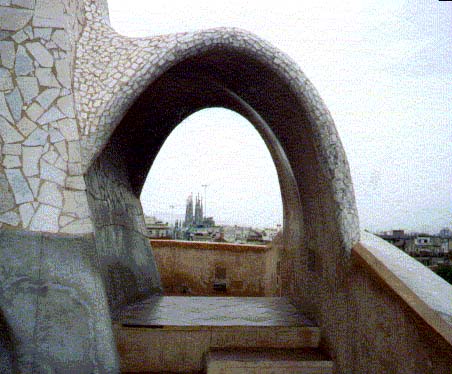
(350, 256, 452, 374)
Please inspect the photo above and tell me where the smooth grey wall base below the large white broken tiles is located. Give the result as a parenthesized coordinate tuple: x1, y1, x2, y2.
(0, 230, 119, 373)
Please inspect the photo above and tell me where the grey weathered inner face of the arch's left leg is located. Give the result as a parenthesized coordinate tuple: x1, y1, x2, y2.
(86, 133, 161, 310)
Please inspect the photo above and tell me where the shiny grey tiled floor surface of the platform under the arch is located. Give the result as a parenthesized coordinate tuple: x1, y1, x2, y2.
(116, 296, 314, 327)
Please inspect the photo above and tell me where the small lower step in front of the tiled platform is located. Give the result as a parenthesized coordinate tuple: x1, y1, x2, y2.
(206, 348, 333, 374)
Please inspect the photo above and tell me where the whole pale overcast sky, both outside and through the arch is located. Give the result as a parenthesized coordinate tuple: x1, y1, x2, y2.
(109, 0, 452, 232)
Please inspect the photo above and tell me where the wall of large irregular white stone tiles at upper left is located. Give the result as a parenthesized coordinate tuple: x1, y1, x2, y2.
(0, 0, 92, 234)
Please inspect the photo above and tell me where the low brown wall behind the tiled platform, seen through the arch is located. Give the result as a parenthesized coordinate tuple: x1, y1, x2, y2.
(151, 240, 281, 296)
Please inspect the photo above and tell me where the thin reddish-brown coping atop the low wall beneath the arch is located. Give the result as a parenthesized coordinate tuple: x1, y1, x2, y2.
(150, 239, 272, 252)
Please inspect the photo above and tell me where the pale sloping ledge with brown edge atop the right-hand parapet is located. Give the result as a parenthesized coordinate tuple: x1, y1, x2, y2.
(352, 232, 452, 345)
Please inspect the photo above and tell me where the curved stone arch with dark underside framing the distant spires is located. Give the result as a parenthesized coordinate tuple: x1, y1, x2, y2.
(86, 42, 358, 310)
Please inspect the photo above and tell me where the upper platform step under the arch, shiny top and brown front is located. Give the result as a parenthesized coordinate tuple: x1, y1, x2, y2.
(114, 296, 320, 373)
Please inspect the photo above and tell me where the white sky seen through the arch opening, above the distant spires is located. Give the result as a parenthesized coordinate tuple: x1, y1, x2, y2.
(140, 108, 283, 231)
